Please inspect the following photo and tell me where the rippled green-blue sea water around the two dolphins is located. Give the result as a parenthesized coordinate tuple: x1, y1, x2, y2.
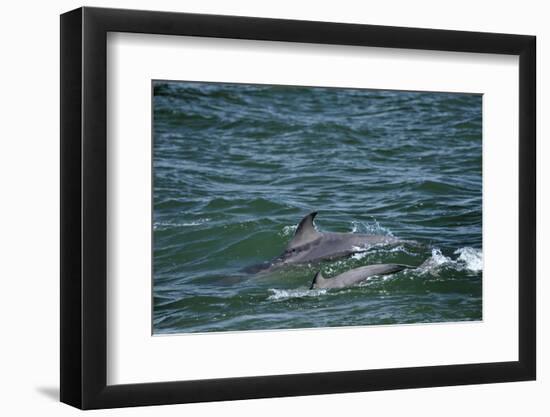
(152, 81, 483, 334)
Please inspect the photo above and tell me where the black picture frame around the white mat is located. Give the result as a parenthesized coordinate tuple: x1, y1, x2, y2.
(60, 7, 536, 409)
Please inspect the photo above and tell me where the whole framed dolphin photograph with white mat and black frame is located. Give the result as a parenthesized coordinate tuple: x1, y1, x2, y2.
(61, 7, 536, 409)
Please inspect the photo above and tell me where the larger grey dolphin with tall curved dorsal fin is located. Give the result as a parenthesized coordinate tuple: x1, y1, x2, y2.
(245, 212, 405, 272)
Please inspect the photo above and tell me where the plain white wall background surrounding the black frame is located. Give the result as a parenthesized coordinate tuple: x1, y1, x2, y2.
(0, 0, 550, 416)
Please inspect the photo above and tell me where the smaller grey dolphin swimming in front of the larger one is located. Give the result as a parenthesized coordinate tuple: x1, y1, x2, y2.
(309, 264, 414, 290)
